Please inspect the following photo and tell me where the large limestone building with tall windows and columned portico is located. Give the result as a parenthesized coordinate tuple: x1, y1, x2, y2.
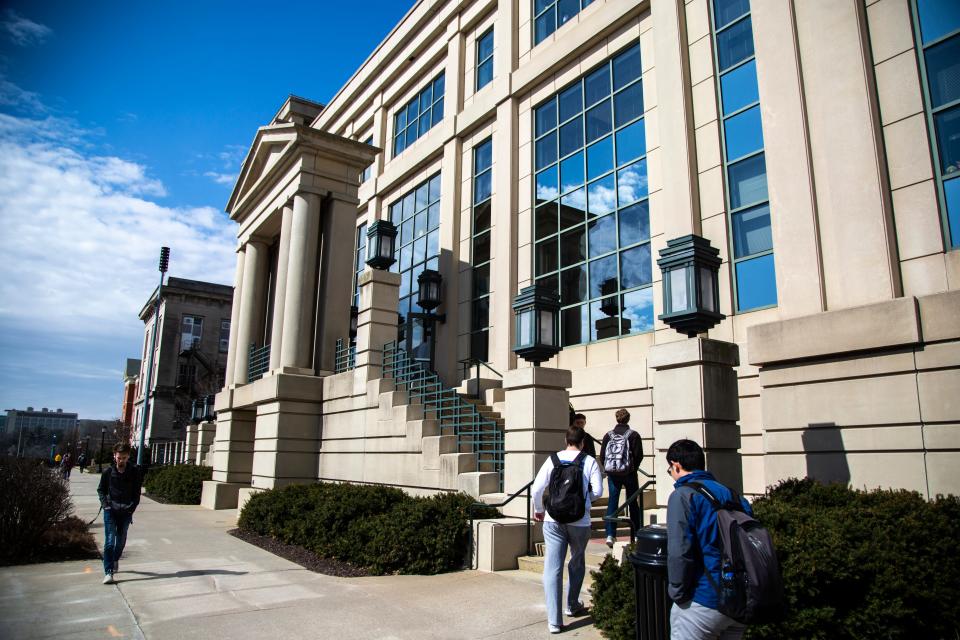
(204, 0, 960, 520)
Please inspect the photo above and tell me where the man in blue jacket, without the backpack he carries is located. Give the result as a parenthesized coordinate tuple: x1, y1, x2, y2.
(667, 440, 753, 640)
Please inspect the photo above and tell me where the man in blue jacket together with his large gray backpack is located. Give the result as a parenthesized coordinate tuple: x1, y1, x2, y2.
(667, 440, 785, 640)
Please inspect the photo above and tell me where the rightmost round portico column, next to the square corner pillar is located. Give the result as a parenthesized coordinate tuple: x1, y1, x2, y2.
(280, 193, 320, 374)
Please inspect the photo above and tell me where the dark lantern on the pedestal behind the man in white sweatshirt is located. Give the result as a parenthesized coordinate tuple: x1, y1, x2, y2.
(513, 285, 560, 366)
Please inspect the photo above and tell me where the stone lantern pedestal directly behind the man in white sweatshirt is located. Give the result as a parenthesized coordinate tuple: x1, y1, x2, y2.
(503, 367, 573, 502)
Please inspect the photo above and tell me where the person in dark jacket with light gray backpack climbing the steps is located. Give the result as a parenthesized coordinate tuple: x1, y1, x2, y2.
(600, 409, 643, 547)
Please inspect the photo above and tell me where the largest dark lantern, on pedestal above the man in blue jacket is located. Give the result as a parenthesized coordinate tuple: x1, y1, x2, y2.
(657, 234, 725, 338)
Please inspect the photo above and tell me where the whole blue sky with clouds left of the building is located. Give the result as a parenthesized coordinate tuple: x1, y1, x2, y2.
(0, 0, 413, 419)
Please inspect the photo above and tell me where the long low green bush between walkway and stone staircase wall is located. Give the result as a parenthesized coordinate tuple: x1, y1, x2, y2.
(238, 483, 496, 574)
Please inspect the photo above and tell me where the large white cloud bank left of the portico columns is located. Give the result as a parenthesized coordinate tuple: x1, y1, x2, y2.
(0, 114, 236, 340)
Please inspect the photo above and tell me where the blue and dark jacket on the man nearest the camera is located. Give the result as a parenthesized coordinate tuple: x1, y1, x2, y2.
(667, 471, 753, 609)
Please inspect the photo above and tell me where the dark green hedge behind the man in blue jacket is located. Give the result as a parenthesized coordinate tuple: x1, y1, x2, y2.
(593, 479, 960, 640)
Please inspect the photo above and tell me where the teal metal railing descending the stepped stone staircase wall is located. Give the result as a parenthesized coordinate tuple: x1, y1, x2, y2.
(383, 342, 504, 491)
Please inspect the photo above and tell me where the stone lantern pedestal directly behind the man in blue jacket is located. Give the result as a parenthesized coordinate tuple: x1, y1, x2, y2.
(647, 338, 743, 506)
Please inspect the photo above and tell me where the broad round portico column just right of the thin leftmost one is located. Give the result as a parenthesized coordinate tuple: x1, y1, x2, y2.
(230, 238, 268, 384)
